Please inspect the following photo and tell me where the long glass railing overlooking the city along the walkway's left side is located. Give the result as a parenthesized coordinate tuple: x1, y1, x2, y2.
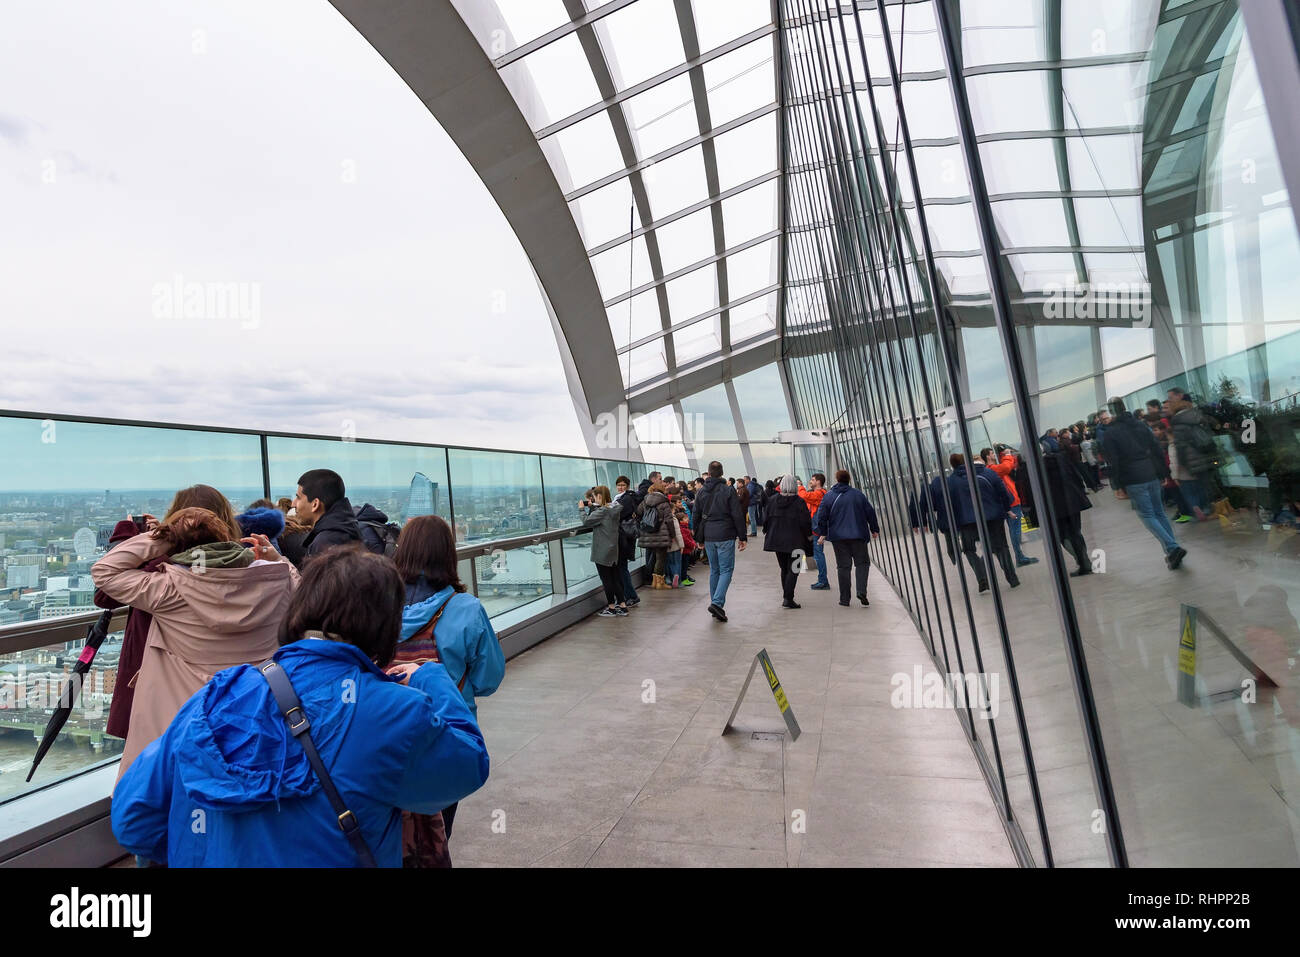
(0, 412, 684, 802)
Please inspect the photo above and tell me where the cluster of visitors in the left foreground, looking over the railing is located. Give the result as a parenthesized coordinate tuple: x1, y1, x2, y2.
(91, 469, 506, 867)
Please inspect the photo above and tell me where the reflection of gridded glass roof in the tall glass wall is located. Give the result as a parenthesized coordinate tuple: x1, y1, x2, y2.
(785, 0, 1170, 325)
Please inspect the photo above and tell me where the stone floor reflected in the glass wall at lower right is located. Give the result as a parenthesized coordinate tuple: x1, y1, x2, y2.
(876, 478, 1300, 867)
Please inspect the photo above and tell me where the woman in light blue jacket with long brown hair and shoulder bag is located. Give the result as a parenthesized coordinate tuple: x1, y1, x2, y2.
(393, 515, 506, 839)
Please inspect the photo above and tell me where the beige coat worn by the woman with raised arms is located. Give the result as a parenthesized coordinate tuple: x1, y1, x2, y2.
(91, 533, 299, 780)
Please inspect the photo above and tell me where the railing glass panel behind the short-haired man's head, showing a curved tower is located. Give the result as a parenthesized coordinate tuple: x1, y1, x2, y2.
(267, 436, 452, 527)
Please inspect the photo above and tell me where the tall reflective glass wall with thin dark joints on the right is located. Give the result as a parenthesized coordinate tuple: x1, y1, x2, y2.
(780, 0, 1300, 866)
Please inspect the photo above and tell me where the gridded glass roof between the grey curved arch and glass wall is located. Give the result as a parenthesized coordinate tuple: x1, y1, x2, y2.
(456, 0, 780, 391)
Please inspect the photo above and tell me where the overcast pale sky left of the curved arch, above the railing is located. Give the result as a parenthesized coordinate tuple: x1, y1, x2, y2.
(0, 0, 586, 454)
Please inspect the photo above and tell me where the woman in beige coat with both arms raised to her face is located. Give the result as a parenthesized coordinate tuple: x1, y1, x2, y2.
(91, 504, 298, 780)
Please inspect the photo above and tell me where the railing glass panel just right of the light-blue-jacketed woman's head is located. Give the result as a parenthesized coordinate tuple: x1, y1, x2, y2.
(449, 449, 550, 546)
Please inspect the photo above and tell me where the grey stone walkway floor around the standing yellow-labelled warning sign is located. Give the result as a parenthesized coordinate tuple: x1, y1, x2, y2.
(451, 547, 1015, 867)
